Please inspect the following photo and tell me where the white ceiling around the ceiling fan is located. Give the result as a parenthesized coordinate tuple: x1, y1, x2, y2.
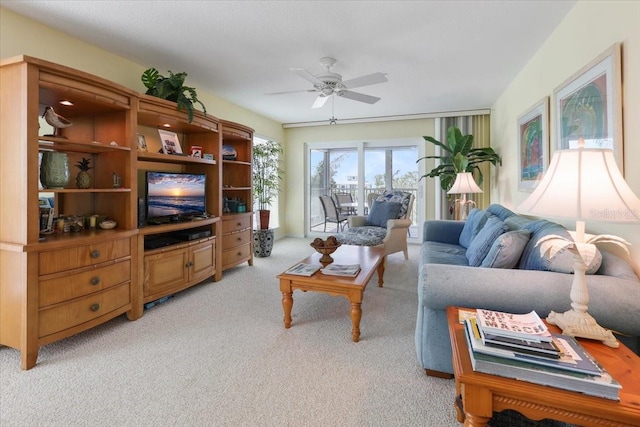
(0, 0, 575, 123)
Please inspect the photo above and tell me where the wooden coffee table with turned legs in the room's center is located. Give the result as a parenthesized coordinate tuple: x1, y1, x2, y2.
(277, 245, 385, 342)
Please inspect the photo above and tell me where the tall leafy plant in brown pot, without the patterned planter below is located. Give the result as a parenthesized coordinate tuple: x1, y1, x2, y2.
(253, 141, 284, 230)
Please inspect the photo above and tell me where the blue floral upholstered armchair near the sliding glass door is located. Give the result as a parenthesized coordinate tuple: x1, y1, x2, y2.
(336, 191, 415, 259)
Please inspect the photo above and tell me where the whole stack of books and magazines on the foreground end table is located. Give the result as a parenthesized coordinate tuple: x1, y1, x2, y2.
(464, 309, 621, 400)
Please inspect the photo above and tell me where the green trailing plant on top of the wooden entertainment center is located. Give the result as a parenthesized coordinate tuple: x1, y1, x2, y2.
(141, 68, 207, 123)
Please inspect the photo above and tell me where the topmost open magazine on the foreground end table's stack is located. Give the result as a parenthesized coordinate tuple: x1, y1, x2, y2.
(476, 308, 551, 342)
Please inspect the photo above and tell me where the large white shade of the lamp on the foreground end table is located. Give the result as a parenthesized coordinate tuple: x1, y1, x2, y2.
(516, 148, 640, 222)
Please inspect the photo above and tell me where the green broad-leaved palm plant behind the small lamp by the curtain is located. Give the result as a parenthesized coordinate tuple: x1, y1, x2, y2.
(417, 126, 502, 191)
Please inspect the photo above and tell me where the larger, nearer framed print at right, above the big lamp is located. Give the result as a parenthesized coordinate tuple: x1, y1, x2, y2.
(553, 43, 624, 171)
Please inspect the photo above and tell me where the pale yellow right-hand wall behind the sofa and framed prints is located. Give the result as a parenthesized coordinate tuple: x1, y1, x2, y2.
(491, 1, 640, 265)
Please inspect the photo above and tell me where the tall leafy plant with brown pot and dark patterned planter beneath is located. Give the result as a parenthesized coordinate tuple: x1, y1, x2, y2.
(253, 140, 284, 256)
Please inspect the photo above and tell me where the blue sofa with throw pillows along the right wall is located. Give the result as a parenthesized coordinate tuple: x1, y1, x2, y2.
(415, 204, 640, 376)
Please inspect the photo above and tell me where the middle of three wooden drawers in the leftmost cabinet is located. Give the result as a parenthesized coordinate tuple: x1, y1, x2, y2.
(38, 260, 131, 308)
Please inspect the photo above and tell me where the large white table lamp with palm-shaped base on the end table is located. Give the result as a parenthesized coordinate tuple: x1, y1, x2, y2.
(516, 140, 640, 348)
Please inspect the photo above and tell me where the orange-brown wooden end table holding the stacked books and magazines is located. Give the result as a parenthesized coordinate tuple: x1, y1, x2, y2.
(447, 307, 640, 427)
